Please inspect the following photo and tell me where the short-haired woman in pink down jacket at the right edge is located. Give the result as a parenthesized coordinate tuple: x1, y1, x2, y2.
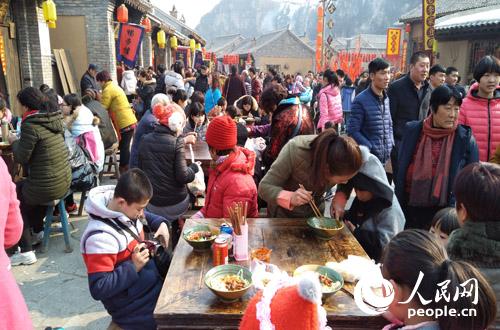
(458, 56, 500, 162)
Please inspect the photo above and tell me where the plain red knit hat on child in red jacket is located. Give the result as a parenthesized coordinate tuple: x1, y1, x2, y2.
(205, 116, 237, 150)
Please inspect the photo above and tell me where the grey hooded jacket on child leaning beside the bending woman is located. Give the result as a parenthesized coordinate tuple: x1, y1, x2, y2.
(342, 146, 406, 259)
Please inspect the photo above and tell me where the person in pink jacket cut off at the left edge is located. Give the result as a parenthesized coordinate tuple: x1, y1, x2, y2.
(0, 158, 33, 330)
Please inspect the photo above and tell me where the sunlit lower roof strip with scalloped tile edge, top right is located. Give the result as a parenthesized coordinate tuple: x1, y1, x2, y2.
(436, 5, 500, 31)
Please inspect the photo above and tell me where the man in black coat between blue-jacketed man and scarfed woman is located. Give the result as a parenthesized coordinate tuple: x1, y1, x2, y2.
(387, 52, 430, 176)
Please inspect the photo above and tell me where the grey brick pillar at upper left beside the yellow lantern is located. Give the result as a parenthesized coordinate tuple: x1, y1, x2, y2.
(12, 0, 52, 88)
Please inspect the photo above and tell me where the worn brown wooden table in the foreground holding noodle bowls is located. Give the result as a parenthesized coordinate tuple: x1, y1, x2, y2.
(154, 218, 388, 329)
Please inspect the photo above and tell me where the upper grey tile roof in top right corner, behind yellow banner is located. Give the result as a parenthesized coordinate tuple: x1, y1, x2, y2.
(399, 0, 500, 22)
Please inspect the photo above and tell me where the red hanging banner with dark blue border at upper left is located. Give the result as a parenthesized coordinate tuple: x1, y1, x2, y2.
(116, 23, 144, 68)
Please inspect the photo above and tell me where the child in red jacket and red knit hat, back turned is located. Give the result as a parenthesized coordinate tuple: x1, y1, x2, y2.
(193, 116, 259, 218)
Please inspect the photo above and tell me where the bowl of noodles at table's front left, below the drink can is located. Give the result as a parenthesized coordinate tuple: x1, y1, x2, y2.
(205, 264, 252, 303)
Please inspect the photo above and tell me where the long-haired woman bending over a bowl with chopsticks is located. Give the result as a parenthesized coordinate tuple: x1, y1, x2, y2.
(259, 129, 363, 218)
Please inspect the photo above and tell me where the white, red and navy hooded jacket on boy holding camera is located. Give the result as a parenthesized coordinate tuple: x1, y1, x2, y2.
(80, 186, 162, 329)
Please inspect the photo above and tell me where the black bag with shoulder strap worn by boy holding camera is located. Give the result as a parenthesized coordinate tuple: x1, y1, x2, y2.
(89, 213, 172, 279)
